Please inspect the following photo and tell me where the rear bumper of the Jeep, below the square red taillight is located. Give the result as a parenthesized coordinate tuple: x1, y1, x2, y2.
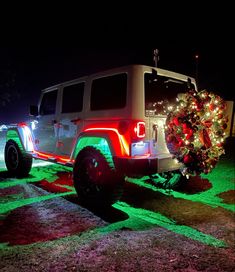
(114, 154, 182, 176)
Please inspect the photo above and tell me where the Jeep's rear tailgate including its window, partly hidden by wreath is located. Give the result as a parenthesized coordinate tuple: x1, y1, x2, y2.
(144, 70, 195, 154)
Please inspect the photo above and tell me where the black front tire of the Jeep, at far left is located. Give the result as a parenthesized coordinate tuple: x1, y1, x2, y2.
(5, 140, 33, 177)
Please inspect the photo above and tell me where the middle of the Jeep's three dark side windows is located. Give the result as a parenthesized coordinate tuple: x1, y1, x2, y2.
(62, 82, 85, 113)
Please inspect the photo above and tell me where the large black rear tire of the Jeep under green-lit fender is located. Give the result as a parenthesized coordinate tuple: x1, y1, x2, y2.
(73, 147, 124, 207)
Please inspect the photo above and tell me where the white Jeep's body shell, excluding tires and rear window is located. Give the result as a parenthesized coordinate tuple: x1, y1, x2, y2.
(6, 65, 196, 174)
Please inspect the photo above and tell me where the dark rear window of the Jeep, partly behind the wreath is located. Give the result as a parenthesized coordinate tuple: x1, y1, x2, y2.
(144, 73, 195, 116)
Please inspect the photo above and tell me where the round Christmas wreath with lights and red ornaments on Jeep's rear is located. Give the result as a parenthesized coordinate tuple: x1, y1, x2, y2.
(165, 90, 228, 175)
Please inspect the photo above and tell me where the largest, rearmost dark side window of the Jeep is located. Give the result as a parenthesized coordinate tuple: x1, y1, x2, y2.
(91, 74, 127, 110)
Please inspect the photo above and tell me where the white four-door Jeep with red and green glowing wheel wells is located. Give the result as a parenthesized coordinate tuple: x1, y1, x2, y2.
(5, 65, 196, 205)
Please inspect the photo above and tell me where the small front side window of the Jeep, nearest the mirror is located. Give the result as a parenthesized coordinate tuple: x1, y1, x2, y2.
(39, 90, 58, 115)
